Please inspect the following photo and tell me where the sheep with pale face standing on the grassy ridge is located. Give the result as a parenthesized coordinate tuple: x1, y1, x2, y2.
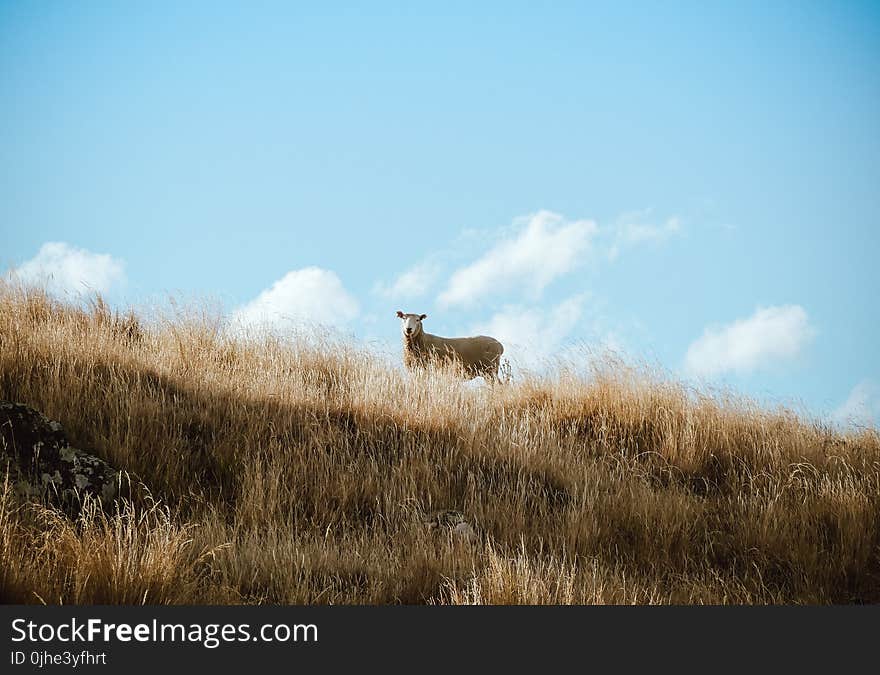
(397, 311, 504, 382)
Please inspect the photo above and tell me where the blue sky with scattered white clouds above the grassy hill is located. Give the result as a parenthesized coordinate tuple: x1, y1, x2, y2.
(0, 1, 880, 428)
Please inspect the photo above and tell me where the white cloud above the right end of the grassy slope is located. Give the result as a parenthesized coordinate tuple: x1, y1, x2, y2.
(684, 305, 815, 376)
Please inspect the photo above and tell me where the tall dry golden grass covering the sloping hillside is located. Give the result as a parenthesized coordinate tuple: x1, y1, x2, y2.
(0, 286, 880, 604)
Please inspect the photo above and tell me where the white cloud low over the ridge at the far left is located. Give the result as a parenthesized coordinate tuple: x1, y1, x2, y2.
(13, 241, 125, 295)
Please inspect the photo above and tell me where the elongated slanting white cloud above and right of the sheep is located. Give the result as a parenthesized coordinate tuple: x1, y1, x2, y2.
(437, 211, 596, 307)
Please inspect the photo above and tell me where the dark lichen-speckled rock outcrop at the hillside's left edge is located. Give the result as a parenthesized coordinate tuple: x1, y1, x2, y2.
(0, 401, 121, 513)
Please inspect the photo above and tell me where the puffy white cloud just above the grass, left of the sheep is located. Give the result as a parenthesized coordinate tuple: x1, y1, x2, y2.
(232, 267, 360, 336)
